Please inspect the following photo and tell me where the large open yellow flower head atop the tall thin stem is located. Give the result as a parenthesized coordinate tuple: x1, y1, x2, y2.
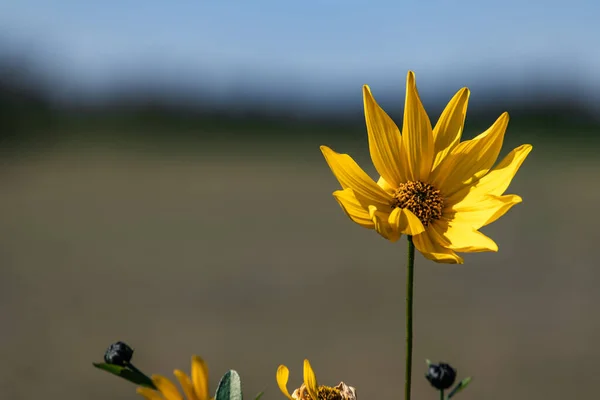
(321, 71, 532, 264)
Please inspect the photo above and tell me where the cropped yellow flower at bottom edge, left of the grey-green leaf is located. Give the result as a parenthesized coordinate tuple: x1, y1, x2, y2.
(137, 356, 212, 400)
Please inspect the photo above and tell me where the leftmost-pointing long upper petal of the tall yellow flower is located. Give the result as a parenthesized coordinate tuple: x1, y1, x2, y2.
(321, 146, 391, 208)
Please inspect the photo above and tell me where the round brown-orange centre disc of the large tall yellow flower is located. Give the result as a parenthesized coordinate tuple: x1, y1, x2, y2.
(392, 181, 444, 226)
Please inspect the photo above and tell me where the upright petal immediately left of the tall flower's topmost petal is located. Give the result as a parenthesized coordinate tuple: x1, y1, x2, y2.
(363, 85, 406, 186)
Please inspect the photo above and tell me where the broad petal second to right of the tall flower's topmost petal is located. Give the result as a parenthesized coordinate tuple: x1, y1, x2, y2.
(431, 113, 509, 196)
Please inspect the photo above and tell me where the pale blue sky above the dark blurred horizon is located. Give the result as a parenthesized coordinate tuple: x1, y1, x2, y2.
(0, 0, 600, 106)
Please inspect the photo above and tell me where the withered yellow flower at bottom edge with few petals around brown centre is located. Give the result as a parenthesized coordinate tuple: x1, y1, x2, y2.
(277, 360, 356, 400)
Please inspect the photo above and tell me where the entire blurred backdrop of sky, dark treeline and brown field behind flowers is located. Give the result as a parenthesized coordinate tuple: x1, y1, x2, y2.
(0, 0, 600, 400)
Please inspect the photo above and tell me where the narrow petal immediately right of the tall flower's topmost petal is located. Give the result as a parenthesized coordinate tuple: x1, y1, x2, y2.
(432, 88, 470, 169)
